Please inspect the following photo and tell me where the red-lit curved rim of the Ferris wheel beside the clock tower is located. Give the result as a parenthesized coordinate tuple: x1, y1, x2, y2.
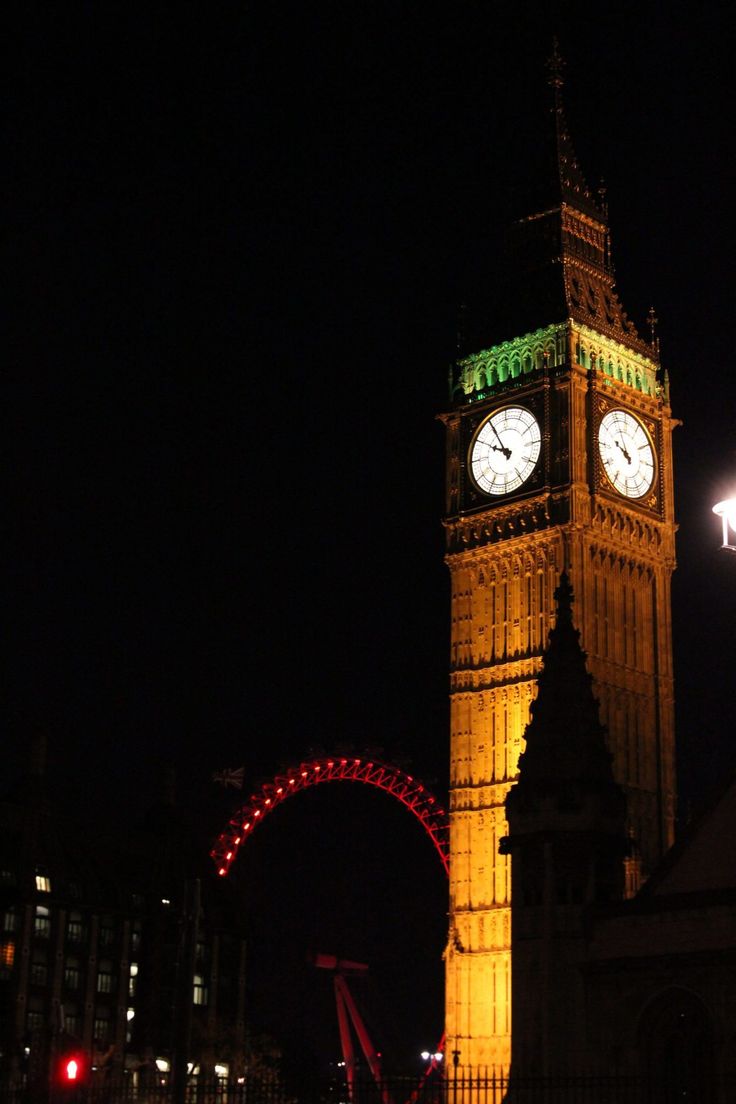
(210, 755, 449, 878)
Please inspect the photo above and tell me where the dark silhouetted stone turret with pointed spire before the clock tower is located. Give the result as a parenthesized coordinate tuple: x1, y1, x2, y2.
(501, 573, 627, 1078)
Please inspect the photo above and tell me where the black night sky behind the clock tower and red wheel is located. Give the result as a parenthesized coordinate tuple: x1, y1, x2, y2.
(3, 2, 736, 1077)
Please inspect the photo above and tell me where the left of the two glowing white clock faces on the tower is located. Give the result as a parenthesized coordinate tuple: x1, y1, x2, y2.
(470, 406, 542, 495)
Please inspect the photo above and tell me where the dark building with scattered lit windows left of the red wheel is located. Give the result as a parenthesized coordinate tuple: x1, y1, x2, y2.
(0, 742, 245, 1084)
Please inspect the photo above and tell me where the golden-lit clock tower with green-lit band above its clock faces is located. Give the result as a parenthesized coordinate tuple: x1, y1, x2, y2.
(444, 57, 675, 1068)
